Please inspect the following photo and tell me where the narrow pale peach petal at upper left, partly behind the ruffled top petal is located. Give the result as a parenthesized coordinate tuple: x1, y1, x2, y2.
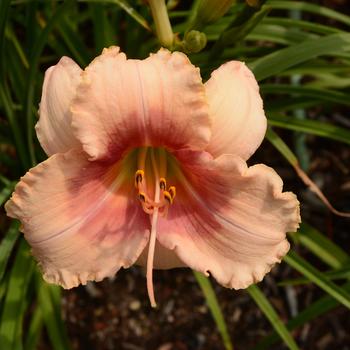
(35, 57, 82, 156)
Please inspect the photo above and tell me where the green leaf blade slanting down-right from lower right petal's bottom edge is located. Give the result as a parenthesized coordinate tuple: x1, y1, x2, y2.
(247, 284, 299, 350)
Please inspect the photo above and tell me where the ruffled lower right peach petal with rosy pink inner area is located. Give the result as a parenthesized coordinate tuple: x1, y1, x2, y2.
(157, 152, 300, 289)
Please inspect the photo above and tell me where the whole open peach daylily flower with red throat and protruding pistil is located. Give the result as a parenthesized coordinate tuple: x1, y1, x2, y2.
(6, 47, 300, 305)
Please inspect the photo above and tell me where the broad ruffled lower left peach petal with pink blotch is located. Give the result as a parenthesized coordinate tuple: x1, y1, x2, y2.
(6, 150, 149, 288)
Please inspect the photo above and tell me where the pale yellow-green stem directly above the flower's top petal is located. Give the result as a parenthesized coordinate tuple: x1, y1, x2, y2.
(148, 0, 174, 49)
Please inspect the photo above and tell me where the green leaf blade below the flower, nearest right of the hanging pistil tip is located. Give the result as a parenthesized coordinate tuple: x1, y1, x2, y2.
(193, 271, 233, 350)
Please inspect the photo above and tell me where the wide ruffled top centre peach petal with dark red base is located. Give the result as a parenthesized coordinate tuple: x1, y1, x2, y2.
(72, 47, 211, 159)
